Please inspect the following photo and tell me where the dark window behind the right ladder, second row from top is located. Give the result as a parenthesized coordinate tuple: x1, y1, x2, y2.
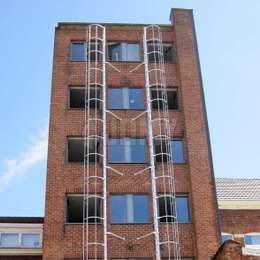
(151, 88, 179, 110)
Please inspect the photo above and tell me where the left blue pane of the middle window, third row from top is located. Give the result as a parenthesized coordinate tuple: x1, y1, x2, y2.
(109, 139, 126, 163)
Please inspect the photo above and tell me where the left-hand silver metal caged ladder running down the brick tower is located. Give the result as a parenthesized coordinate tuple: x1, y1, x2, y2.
(83, 24, 107, 260)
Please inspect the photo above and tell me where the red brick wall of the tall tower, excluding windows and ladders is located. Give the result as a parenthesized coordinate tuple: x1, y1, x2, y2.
(43, 10, 218, 260)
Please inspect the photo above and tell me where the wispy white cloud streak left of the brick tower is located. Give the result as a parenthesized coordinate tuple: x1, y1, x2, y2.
(0, 126, 48, 191)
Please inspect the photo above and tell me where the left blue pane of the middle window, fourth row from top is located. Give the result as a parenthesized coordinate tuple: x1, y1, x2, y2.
(110, 195, 127, 224)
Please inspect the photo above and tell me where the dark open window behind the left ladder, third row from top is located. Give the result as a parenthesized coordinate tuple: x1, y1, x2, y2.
(68, 137, 99, 163)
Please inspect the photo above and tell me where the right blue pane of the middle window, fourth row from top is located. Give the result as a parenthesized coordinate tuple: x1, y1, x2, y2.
(133, 195, 150, 223)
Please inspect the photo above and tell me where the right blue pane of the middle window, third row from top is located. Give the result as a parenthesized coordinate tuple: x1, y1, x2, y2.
(131, 138, 146, 163)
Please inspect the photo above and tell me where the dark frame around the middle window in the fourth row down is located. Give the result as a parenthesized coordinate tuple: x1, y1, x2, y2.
(109, 192, 152, 225)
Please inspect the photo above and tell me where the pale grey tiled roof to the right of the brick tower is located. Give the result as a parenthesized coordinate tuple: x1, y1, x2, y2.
(216, 178, 260, 201)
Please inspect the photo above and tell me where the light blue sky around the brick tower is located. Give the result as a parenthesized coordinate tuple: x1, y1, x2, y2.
(0, 0, 260, 216)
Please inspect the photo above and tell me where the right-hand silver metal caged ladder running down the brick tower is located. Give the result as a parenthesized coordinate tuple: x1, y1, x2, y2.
(143, 25, 181, 260)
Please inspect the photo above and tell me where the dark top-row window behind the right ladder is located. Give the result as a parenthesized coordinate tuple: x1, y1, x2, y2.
(148, 43, 176, 62)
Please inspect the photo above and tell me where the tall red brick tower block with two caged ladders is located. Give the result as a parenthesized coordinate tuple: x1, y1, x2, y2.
(43, 9, 220, 260)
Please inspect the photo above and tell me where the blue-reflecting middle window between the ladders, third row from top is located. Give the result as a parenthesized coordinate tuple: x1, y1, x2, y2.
(109, 138, 146, 163)
